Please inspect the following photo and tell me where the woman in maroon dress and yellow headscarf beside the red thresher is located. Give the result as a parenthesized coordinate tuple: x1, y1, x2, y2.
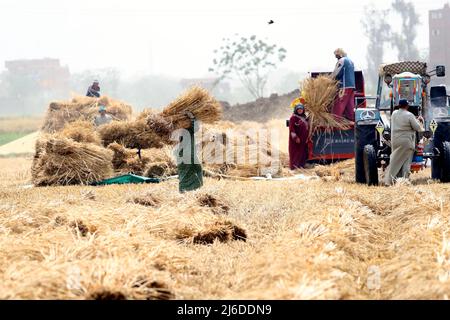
(289, 99, 309, 170)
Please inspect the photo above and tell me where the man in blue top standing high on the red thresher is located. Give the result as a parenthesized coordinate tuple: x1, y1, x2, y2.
(331, 48, 356, 122)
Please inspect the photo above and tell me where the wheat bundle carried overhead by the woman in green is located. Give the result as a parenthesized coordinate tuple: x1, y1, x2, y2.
(161, 87, 222, 129)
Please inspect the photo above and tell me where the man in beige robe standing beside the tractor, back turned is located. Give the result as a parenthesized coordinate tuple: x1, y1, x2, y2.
(384, 99, 424, 185)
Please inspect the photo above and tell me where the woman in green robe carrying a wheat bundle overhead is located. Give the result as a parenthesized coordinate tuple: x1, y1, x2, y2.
(177, 112, 203, 193)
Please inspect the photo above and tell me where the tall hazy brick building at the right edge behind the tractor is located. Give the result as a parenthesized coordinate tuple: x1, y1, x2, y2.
(429, 3, 450, 87)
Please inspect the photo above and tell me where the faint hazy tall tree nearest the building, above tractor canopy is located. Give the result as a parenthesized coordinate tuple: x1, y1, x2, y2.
(391, 0, 420, 61)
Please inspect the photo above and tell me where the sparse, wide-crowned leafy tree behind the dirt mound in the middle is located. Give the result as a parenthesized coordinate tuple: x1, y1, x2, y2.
(209, 34, 286, 99)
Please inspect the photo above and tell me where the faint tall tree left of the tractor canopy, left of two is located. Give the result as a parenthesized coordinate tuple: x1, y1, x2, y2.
(361, 6, 391, 92)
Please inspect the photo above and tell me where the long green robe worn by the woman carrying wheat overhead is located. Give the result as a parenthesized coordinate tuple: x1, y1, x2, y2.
(178, 120, 203, 192)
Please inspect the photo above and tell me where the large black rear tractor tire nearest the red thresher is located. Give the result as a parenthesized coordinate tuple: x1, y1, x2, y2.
(355, 125, 377, 183)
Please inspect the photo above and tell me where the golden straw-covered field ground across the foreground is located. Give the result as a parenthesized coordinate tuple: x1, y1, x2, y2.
(0, 158, 450, 299)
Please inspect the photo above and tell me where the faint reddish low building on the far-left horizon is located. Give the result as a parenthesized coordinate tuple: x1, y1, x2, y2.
(5, 58, 70, 92)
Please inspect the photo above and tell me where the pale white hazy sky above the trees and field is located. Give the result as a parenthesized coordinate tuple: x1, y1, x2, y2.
(0, 0, 448, 77)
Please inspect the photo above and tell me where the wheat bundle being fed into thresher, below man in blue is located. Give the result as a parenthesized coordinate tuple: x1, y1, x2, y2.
(301, 76, 352, 135)
